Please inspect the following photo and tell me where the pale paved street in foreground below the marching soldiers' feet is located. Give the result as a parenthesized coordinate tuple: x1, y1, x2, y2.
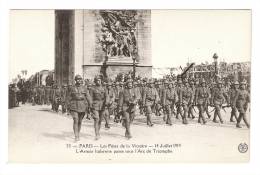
(9, 104, 250, 163)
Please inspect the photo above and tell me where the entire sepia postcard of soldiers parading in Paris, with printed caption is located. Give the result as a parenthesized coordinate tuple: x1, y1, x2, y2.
(6, 9, 252, 163)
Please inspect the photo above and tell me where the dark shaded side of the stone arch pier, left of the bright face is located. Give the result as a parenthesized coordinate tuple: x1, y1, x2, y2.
(54, 10, 75, 85)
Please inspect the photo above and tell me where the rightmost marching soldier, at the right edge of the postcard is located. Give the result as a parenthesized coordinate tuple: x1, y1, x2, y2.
(234, 80, 250, 128)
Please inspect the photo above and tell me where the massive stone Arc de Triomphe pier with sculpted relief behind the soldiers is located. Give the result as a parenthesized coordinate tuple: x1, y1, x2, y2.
(54, 10, 152, 84)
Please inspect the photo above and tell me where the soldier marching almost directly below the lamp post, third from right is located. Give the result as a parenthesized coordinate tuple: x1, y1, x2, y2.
(211, 80, 229, 123)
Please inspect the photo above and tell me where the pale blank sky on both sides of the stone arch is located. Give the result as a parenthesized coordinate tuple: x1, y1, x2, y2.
(9, 10, 251, 81)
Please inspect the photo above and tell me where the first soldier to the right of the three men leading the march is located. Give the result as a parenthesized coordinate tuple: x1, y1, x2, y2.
(143, 79, 160, 127)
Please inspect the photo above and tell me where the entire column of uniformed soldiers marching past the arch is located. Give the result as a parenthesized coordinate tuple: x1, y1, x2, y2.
(9, 75, 250, 141)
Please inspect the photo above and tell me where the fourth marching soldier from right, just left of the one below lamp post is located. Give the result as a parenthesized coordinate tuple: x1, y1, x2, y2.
(195, 79, 210, 124)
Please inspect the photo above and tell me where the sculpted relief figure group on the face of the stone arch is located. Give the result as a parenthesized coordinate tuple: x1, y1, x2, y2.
(100, 10, 137, 57)
